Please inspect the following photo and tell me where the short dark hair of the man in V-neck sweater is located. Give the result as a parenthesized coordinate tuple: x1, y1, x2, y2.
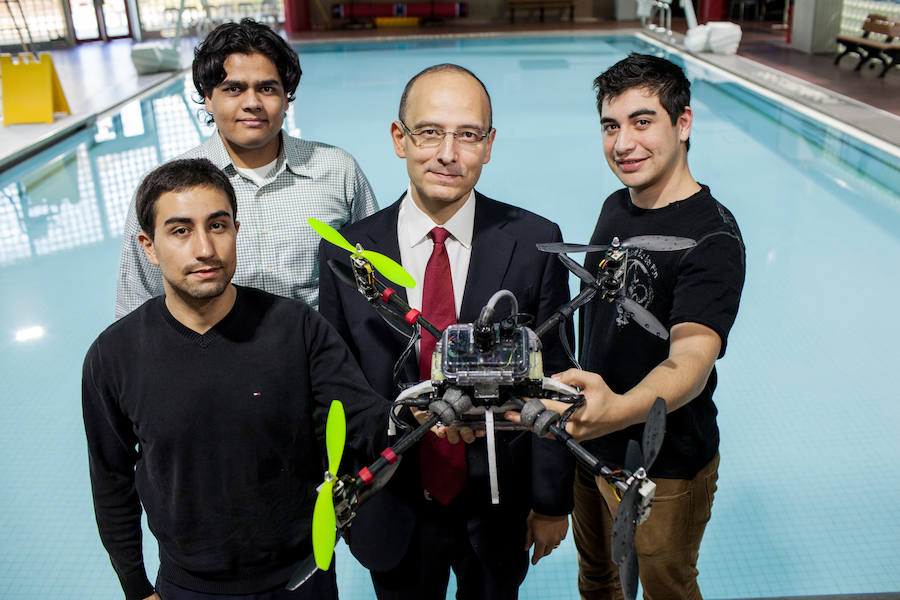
(135, 158, 237, 240)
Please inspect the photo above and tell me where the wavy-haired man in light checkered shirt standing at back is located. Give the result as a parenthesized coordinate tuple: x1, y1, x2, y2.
(115, 19, 378, 319)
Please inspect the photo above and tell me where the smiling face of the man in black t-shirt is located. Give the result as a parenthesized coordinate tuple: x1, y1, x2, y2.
(600, 88, 693, 192)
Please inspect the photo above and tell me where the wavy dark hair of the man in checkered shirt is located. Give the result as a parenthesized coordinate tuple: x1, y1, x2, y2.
(191, 19, 303, 123)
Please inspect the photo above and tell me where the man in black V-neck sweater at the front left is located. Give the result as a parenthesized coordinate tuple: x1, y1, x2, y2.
(82, 159, 387, 600)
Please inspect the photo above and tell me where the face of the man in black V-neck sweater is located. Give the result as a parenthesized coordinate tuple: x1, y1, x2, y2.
(138, 186, 239, 304)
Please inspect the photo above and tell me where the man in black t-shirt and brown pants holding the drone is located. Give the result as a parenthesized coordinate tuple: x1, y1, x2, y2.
(520, 54, 744, 600)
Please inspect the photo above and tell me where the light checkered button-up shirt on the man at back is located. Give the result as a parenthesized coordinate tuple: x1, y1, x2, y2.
(115, 132, 378, 319)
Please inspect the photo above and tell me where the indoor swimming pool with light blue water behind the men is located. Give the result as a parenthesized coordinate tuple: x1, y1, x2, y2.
(0, 35, 900, 599)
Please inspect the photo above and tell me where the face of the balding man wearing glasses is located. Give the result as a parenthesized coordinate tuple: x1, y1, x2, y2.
(391, 71, 495, 214)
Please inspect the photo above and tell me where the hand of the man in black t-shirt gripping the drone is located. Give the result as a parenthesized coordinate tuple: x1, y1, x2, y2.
(503, 369, 626, 442)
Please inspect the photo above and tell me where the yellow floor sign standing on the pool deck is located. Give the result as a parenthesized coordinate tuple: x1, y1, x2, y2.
(0, 53, 72, 125)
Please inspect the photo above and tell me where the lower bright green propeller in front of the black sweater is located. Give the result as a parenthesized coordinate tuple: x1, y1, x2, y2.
(313, 400, 347, 571)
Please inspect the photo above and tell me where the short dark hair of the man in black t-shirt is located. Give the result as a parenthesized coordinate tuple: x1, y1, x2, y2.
(594, 52, 691, 148)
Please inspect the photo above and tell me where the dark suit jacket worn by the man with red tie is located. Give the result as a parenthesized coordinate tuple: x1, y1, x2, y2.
(319, 192, 574, 571)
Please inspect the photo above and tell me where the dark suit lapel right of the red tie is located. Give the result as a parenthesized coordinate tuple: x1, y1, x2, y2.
(459, 192, 516, 323)
